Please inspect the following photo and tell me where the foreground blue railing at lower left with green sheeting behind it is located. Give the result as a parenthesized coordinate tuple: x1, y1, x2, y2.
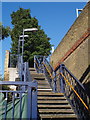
(0, 81, 37, 120)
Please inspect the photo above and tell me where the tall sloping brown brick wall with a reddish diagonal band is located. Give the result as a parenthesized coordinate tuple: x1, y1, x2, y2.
(50, 2, 90, 87)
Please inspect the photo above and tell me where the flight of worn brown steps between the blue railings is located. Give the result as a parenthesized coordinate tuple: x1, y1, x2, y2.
(30, 68, 77, 120)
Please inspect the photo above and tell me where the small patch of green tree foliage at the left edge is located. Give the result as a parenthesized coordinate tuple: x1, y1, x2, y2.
(0, 23, 10, 40)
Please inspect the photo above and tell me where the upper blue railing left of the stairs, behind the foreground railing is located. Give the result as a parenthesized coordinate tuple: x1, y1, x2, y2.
(8, 54, 32, 82)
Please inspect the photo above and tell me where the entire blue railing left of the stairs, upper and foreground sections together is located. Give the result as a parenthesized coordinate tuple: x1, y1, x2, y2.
(0, 54, 37, 120)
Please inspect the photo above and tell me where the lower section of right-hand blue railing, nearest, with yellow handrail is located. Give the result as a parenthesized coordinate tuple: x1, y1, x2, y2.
(55, 64, 90, 120)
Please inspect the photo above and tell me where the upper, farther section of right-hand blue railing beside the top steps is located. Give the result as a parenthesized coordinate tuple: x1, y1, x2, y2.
(34, 55, 56, 91)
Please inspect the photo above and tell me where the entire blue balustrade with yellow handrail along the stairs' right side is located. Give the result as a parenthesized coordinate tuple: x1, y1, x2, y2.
(34, 56, 90, 120)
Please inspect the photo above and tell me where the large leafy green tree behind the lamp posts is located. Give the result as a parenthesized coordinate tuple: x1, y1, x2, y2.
(11, 8, 51, 66)
